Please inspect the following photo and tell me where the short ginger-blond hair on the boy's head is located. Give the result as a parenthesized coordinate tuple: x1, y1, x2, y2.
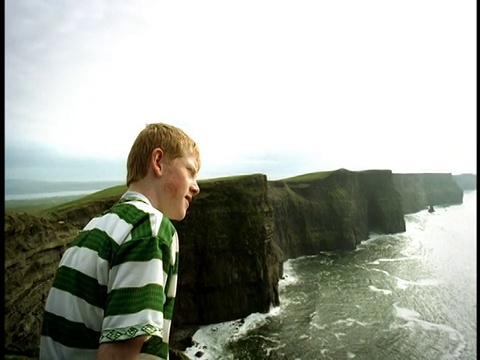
(127, 123, 200, 186)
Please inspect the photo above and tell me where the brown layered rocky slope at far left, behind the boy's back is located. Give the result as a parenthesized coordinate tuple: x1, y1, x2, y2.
(5, 214, 78, 355)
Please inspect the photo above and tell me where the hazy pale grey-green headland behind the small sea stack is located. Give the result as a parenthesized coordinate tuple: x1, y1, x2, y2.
(393, 173, 463, 214)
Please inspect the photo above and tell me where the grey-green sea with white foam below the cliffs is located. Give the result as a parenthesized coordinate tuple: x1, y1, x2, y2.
(187, 191, 477, 360)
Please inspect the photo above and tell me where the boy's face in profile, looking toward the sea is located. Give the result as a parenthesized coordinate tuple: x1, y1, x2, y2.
(159, 154, 200, 220)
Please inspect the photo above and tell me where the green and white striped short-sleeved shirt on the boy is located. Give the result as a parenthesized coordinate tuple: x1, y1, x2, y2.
(40, 191, 178, 360)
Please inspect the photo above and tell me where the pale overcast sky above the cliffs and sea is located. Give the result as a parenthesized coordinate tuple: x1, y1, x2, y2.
(5, 0, 477, 182)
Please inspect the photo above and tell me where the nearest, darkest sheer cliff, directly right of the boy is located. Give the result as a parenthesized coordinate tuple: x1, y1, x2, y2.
(174, 175, 283, 327)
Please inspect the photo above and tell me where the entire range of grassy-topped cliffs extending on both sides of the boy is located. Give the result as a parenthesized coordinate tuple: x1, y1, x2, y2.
(5, 169, 463, 360)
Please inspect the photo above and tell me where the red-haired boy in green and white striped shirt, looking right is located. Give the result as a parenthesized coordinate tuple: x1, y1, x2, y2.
(40, 123, 200, 360)
